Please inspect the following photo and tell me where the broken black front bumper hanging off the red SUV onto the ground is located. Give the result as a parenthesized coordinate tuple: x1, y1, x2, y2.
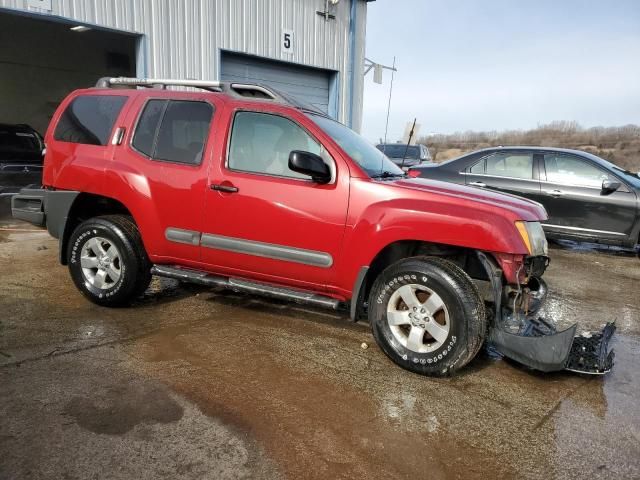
(478, 253, 616, 375)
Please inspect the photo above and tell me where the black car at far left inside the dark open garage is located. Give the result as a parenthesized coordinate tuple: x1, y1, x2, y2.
(0, 123, 44, 193)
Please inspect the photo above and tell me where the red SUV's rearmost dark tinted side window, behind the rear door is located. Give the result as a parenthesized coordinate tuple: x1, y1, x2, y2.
(53, 95, 127, 145)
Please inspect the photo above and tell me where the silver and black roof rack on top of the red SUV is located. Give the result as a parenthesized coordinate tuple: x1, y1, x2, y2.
(96, 77, 326, 115)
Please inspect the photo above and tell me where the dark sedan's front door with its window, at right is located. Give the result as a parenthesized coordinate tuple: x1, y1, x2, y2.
(541, 152, 636, 241)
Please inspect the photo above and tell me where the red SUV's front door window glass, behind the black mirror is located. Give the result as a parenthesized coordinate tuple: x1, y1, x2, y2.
(228, 112, 321, 179)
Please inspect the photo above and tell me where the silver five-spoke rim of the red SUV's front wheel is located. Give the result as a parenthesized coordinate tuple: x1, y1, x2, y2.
(387, 283, 451, 353)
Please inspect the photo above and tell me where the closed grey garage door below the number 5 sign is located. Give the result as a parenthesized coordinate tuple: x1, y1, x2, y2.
(220, 52, 332, 113)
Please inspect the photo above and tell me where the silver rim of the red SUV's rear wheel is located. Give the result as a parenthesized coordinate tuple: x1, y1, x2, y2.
(80, 237, 122, 290)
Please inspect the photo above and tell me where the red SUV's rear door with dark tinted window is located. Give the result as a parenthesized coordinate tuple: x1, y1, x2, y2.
(106, 92, 216, 262)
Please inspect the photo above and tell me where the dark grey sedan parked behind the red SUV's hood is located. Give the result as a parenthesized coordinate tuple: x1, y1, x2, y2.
(409, 147, 640, 247)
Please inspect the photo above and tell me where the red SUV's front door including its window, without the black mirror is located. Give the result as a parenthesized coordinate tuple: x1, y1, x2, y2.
(202, 111, 349, 289)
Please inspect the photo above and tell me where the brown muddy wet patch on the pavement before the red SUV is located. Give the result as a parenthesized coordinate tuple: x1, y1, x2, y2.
(129, 311, 509, 479)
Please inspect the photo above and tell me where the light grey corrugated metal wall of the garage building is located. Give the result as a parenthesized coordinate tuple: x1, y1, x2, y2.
(0, 0, 366, 128)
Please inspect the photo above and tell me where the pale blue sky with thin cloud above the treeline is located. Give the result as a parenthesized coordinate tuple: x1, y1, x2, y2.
(362, 0, 640, 141)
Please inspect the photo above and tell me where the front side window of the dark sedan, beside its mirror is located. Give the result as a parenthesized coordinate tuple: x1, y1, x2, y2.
(544, 153, 613, 188)
